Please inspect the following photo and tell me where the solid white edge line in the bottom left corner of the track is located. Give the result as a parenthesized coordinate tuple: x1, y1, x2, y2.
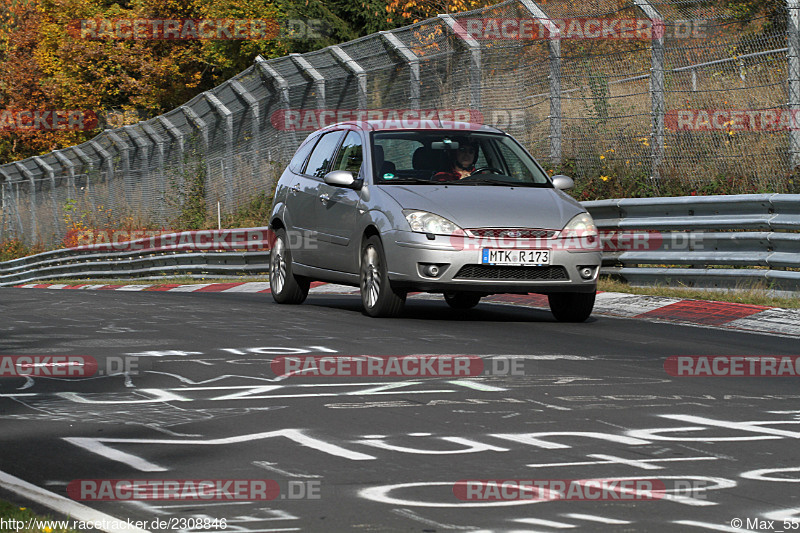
(0, 471, 148, 533)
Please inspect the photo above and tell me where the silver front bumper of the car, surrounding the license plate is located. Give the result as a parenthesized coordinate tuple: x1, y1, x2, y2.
(383, 231, 602, 294)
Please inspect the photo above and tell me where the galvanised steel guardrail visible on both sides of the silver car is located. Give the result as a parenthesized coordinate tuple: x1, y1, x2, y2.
(0, 194, 800, 291)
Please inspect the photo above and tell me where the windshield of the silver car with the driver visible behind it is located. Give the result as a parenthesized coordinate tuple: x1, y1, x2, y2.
(372, 130, 552, 187)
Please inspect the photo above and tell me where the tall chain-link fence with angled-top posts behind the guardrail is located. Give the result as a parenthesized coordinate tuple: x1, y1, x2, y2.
(0, 0, 800, 245)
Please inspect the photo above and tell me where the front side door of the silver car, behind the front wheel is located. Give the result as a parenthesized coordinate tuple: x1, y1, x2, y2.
(314, 130, 364, 272)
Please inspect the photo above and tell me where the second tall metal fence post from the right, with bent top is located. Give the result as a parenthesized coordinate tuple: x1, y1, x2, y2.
(634, 0, 666, 179)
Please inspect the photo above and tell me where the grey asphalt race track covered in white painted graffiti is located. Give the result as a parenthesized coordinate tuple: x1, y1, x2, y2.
(0, 289, 800, 532)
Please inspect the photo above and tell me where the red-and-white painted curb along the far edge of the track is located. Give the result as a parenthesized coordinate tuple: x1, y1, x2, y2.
(12, 282, 800, 336)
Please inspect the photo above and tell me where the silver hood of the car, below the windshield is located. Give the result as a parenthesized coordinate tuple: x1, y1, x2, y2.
(381, 185, 585, 229)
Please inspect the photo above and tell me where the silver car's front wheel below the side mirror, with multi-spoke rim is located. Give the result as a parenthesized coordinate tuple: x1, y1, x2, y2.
(359, 235, 406, 317)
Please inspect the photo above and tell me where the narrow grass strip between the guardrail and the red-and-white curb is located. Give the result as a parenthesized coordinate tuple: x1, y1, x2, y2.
(14, 276, 800, 309)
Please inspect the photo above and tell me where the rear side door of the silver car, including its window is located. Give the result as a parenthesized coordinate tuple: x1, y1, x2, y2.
(285, 130, 343, 265)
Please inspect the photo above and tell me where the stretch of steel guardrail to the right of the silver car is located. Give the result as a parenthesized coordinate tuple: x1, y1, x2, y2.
(583, 194, 800, 291)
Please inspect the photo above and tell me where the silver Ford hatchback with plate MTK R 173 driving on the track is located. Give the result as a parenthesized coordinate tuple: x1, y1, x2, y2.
(270, 121, 601, 322)
